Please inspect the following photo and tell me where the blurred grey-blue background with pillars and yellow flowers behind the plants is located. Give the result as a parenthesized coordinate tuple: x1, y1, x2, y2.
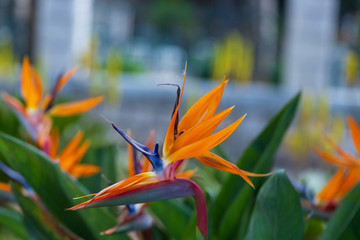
(0, 0, 360, 177)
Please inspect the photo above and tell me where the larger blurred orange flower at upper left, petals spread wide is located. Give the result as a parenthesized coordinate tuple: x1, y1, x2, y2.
(2, 57, 103, 152)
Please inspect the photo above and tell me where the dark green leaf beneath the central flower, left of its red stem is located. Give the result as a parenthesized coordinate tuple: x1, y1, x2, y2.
(147, 199, 196, 239)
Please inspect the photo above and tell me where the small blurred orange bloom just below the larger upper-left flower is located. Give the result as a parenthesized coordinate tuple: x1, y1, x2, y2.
(49, 131, 100, 178)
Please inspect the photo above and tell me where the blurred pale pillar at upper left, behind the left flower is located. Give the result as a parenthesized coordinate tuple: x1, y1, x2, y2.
(35, 0, 93, 81)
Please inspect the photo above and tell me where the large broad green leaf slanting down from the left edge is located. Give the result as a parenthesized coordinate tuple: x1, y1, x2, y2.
(0, 133, 125, 239)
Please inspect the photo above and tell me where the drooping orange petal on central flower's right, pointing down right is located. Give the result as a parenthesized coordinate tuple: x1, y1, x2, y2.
(196, 152, 255, 188)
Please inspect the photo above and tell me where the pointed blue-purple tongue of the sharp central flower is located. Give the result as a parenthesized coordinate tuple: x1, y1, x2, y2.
(110, 122, 163, 173)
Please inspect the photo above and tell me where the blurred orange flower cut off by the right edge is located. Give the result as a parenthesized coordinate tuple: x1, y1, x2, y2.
(315, 116, 360, 210)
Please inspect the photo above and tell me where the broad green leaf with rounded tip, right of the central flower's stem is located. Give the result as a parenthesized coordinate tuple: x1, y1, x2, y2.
(245, 171, 304, 240)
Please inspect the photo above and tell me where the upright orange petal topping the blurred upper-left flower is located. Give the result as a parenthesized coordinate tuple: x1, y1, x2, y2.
(20, 57, 42, 108)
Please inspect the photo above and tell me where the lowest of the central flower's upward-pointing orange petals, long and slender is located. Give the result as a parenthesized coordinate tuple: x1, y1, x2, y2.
(167, 114, 246, 162)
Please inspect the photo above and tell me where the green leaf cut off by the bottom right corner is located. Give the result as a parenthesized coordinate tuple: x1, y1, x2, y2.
(320, 183, 360, 240)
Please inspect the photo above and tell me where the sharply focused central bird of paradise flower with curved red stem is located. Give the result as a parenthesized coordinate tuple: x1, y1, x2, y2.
(69, 67, 269, 238)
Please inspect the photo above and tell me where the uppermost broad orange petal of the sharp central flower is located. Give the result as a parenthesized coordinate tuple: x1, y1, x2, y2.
(179, 79, 228, 132)
